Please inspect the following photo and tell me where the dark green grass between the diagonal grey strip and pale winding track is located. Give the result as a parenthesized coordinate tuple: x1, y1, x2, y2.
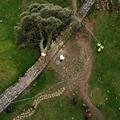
(0, 69, 58, 120)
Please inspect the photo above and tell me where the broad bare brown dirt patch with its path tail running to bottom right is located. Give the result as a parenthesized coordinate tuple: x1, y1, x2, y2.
(50, 21, 104, 120)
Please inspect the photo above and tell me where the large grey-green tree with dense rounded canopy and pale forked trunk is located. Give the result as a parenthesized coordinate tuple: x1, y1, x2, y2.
(16, 3, 72, 52)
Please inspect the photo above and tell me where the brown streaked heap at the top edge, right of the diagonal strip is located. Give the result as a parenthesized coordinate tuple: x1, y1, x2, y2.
(95, 0, 116, 11)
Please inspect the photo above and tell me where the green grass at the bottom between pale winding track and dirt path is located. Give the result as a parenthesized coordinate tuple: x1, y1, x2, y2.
(28, 96, 84, 120)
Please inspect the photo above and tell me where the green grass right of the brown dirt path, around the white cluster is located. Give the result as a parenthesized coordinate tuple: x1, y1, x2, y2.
(90, 12, 120, 120)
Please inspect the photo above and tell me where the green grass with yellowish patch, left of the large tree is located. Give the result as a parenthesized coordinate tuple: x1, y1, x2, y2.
(0, 0, 37, 93)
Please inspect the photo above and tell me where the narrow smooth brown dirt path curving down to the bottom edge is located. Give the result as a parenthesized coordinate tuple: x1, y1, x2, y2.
(79, 23, 104, 120)
